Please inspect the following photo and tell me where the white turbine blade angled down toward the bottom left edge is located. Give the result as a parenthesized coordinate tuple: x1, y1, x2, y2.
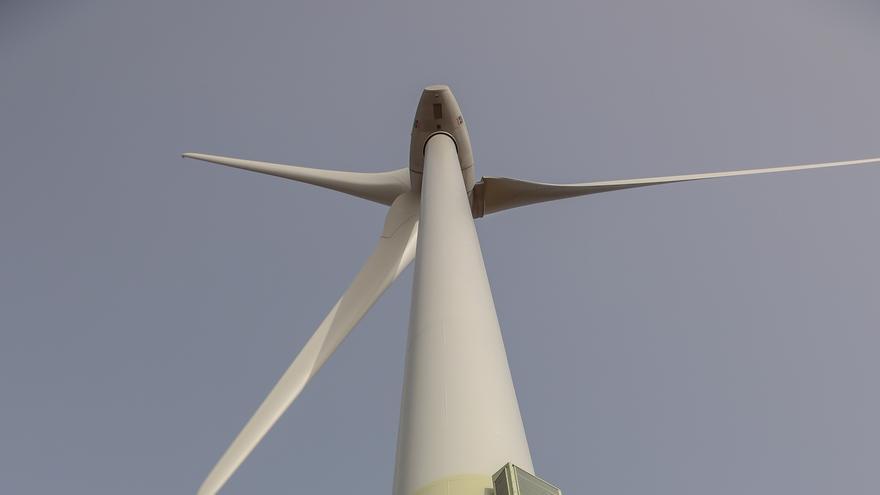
(198, 193, 419, 495)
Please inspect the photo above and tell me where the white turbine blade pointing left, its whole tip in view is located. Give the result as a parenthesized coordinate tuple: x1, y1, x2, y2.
(183, 153, 410, 205)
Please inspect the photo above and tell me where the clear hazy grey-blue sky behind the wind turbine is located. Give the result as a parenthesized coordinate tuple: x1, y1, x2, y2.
(0, 0, 880, 495)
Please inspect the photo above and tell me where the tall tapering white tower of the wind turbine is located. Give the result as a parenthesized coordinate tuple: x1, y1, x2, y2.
(394, 134, 532, 495)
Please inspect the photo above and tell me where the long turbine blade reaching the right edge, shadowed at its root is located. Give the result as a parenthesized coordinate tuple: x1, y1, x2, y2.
(473, 158, 880, 217)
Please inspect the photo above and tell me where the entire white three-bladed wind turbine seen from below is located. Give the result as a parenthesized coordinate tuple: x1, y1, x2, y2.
(183, 85, 880, 495)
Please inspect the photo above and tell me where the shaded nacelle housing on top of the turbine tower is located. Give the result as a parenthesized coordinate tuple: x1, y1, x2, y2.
(409, 84, 476, 194)
